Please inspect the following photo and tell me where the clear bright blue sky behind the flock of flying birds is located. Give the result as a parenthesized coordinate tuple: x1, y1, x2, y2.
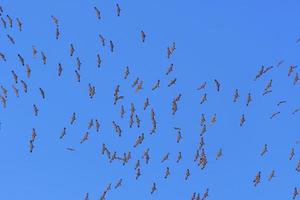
(0, 0, 300, 200)
